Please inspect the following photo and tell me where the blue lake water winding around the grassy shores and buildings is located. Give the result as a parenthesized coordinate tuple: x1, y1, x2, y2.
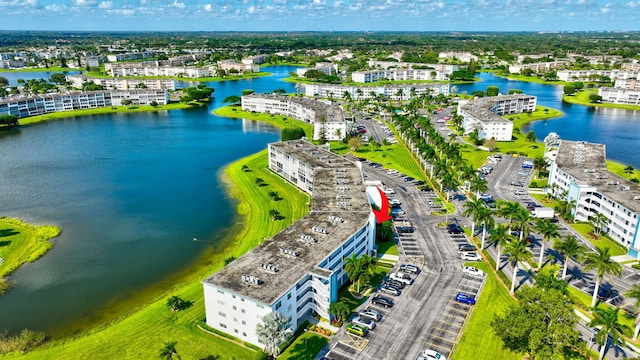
(0, 67, 640, 333)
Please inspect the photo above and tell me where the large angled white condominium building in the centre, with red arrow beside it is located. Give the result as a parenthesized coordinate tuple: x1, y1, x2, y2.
(202, 140, 376, 346)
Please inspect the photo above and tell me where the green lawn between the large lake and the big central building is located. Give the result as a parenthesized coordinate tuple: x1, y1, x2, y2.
(6, 150, 308, 360)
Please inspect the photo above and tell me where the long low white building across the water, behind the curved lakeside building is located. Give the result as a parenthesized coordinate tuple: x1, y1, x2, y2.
(304, 83, 449, 101)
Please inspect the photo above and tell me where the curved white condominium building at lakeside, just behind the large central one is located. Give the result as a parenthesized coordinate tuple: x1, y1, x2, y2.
(242, 94, 349, 140)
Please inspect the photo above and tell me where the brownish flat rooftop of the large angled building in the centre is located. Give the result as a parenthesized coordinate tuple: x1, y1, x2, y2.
(204, 140, 371, 305)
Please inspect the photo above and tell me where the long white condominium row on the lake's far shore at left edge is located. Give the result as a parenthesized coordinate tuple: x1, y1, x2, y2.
(0, 90, 169, 118)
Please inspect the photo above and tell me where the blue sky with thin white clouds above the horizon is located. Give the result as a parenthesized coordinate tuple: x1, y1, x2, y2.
(0, 0, 640, 31)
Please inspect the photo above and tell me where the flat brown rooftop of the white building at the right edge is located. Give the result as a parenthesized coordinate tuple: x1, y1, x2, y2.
(556, 140, 640, 212)
